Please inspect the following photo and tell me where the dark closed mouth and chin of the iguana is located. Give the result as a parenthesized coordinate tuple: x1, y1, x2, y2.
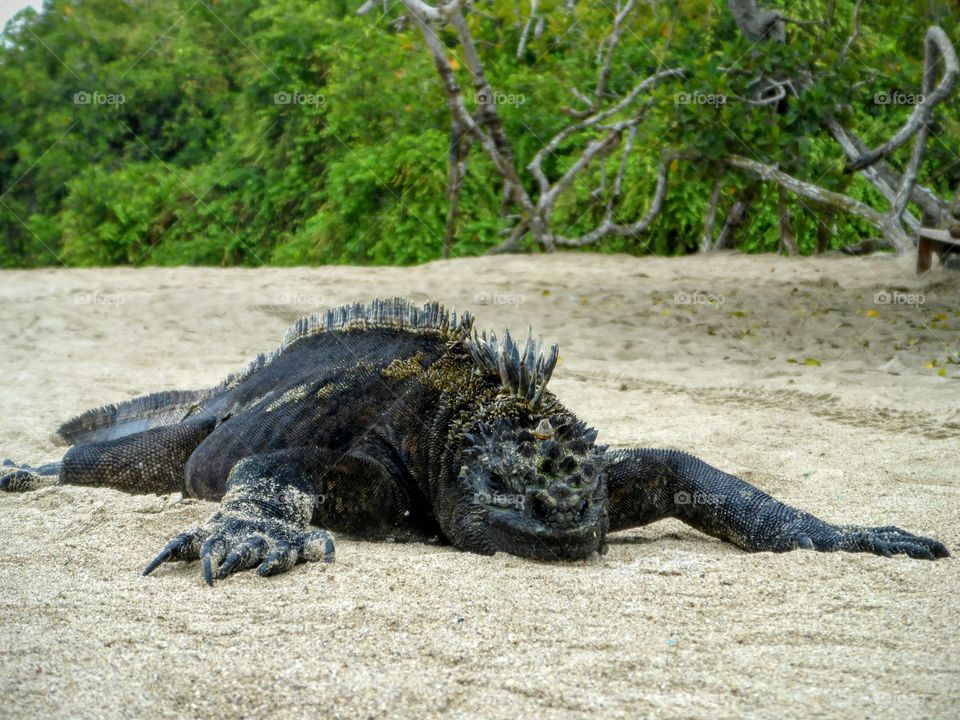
(487, 504, 606, 560)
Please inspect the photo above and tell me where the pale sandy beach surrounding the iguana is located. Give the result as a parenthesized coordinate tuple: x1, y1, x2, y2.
(0, 253, 960, 718)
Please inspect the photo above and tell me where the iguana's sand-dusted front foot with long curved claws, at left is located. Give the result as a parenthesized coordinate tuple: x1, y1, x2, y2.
(143, 512, 334, 586)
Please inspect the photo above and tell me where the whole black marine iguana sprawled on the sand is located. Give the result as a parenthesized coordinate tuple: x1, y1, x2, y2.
(0, 299, 949, 585)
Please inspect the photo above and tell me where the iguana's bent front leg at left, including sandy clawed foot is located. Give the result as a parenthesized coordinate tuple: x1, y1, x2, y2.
(143, 449, 334, 585)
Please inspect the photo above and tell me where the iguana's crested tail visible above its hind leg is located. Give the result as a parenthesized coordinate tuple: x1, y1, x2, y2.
(54, 390, 213, 445)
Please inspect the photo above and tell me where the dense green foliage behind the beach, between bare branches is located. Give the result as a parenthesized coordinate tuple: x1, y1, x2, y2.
(0, 0, 960, 267)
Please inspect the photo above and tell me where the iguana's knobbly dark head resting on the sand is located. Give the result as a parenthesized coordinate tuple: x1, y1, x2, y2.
(454, 415, 609, 560)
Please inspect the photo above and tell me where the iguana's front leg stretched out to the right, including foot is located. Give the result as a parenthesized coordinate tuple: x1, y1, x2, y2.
(607, 450, 950, 560)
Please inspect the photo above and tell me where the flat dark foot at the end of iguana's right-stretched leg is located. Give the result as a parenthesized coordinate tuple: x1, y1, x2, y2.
(770, 523, 950, 560)
